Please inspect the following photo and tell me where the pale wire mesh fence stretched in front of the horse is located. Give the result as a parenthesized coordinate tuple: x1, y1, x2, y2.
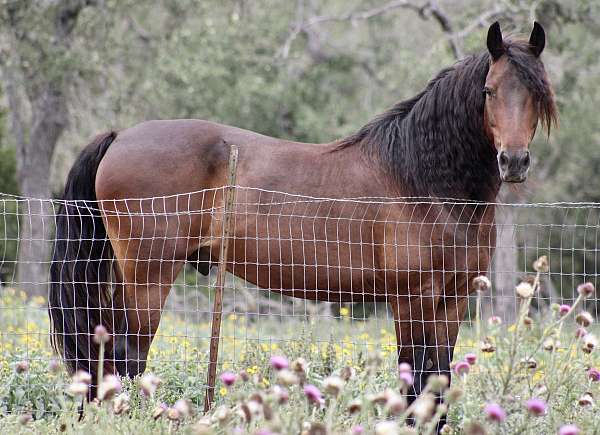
(0, 187, 600, 416)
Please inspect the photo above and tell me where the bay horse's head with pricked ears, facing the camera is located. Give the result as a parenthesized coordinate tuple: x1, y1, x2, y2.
(483, 22, 557, 183)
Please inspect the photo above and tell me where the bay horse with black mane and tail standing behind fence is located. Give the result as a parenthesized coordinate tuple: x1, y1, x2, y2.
(50, 23, 557, 408)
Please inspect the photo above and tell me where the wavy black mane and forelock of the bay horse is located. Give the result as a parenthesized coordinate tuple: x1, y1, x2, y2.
(338, 39, 556, 201)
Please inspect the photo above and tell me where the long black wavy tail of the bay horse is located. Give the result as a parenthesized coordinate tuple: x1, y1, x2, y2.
(48, 132, 122, 381)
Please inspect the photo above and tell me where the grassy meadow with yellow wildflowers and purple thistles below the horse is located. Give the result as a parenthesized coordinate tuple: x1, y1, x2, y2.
(0, 274, 600, 435)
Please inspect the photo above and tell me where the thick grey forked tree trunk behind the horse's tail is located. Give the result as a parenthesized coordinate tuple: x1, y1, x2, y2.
(0, 0, 95, 296)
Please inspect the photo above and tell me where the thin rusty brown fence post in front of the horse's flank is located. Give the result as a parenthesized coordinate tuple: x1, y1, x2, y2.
(204, 145, 238, 412)
